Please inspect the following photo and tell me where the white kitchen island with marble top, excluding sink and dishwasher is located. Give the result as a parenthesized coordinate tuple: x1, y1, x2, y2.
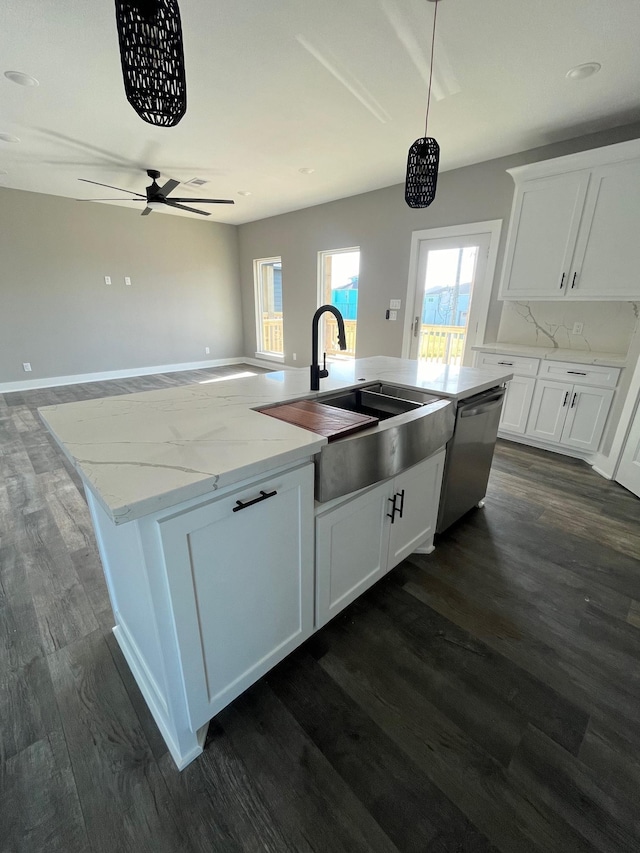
(40, 357, 510, 768)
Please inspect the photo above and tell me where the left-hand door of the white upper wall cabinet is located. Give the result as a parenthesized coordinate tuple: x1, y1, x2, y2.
(500, 170, 590, 299)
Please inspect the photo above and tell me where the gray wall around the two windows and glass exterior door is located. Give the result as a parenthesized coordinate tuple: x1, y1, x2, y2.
(240, 123, 640, 366)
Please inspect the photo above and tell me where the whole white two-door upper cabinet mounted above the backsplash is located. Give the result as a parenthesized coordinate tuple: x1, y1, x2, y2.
(500, 140, 640, 301)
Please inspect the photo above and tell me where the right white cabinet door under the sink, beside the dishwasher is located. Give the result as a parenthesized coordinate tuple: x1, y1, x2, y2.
(388, 450, 445, 569)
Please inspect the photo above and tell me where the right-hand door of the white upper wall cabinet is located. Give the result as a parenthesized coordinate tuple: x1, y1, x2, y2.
(569, 160, 640, 299)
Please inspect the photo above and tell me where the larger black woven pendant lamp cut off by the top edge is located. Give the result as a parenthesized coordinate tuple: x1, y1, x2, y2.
(115, 0, 187, 127)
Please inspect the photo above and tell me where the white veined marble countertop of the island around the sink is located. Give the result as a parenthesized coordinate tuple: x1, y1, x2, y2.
(39, 356, 512, 524)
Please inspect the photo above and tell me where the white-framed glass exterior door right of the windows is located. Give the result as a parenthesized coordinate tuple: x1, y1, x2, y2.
(403, 222, 500, 366)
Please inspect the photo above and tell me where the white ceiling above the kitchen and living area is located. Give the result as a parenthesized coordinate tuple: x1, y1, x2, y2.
(0, 0, 640, 223)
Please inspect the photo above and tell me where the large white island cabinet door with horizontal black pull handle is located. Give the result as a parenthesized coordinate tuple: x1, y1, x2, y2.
(159, 465, 313, 731)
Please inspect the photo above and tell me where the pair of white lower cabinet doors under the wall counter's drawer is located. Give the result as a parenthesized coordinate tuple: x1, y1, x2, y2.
(526, 379, 613, 452)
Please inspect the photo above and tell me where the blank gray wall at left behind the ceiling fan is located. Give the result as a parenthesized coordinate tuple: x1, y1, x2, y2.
(0, 189, 243, 382)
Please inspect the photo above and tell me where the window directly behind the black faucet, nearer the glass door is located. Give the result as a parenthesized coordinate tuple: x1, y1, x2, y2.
(318, 247, 360, 358)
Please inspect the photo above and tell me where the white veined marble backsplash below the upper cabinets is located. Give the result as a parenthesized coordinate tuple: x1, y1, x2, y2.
(497, 301, 640, 355)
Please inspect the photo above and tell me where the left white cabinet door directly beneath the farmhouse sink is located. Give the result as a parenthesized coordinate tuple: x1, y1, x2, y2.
(316, 482, 392, 628)
